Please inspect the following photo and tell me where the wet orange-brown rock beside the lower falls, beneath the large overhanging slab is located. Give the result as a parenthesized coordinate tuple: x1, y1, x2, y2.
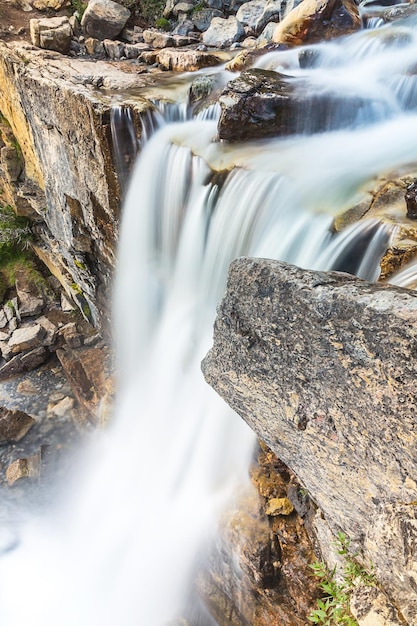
(198, 447, 316, 626)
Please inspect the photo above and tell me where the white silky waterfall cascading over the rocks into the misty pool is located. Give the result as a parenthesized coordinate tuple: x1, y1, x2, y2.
(0, 13, 417, 626)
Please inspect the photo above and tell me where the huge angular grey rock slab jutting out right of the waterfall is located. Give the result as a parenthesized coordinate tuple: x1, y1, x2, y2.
(203, 259, 417, 625)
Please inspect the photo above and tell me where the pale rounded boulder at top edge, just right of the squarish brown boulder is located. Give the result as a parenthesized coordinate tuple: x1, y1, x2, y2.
(81, 0, 130, 40)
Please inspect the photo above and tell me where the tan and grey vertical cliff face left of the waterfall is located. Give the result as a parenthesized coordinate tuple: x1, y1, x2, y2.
(0, 42, 148, 327)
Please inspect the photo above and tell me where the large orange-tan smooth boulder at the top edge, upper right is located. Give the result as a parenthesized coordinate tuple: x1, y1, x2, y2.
(273, 0, 362, 46)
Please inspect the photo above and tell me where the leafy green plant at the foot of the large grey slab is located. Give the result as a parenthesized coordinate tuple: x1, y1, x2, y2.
(308, 532, 375, 626)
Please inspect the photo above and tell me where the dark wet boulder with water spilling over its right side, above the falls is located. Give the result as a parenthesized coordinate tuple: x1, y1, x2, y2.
(218, 69, 384, 141)
